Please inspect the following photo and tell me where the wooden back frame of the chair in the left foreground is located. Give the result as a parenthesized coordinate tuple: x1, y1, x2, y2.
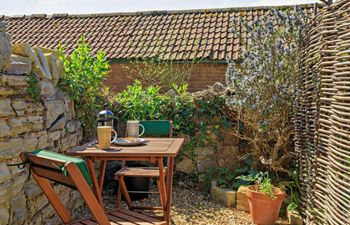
(20, 151, 110, 225)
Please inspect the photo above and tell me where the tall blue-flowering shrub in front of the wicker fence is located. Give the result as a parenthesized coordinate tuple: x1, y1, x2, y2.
(227, 9, 306, 173)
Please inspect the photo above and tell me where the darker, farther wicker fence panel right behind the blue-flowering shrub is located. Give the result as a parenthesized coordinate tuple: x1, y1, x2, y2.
(295, 8, 321, 222)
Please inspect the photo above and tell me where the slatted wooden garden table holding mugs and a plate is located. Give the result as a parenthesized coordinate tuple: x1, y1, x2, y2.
(67, 138, 184, 224)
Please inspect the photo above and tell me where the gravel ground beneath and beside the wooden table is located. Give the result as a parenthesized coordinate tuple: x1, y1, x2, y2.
(104, 179, 288, 225)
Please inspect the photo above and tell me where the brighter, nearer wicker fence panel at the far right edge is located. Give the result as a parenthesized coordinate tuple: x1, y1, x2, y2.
(327, 0, 350, 224)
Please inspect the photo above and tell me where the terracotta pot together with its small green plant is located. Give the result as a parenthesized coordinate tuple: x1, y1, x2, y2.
(246, 178, 285, 225)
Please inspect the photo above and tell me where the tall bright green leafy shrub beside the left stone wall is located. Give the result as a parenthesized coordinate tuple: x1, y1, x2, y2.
(59, 37, 109, 137)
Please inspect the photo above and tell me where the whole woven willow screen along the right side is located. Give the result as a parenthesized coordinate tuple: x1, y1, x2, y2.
(295, 0, 350, 225)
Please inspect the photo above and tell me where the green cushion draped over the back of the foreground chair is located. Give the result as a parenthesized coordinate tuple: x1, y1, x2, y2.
(32, 150, 92, 187)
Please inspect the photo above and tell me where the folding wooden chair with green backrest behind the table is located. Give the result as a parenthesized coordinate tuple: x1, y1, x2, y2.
(114, 120, 173, 210)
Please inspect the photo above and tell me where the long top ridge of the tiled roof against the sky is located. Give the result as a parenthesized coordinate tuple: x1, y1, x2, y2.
(2, 2, 324, 19)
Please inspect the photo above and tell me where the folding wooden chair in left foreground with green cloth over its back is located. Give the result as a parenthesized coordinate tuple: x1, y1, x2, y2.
(20, 150, 166, 225)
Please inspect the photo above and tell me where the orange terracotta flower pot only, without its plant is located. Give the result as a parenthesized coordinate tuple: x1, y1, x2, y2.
(247, 185, 285, 225)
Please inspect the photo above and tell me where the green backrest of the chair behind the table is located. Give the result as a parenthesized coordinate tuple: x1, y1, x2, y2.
(140, 120, 173, 137)
